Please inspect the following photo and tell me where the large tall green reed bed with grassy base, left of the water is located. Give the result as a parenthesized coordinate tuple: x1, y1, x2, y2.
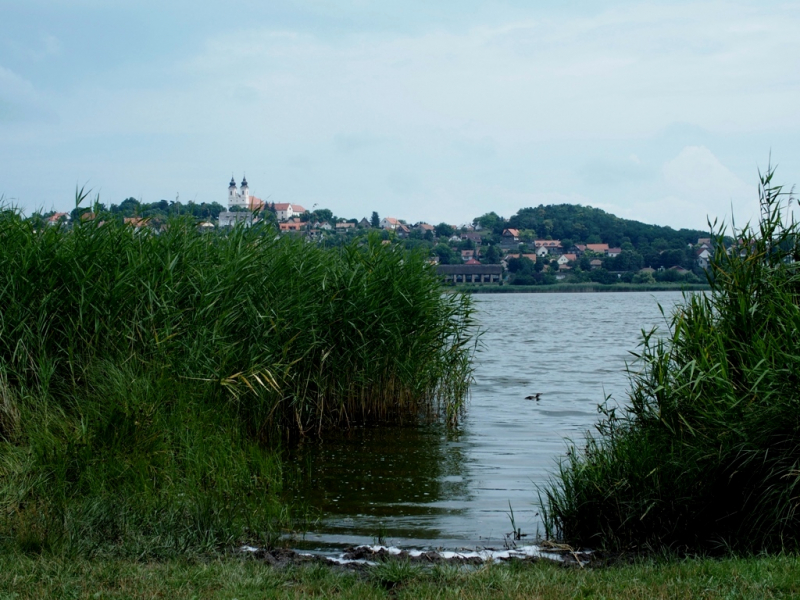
(0, 198, 474, 554)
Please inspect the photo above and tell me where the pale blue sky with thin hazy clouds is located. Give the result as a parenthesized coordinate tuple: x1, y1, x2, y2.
(0, 0, 800, 229)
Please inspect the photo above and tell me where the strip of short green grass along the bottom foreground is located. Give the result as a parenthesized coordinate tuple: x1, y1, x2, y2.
(0, 555, 800, 600)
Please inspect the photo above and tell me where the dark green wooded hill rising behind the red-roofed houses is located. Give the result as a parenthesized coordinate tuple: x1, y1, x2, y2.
(475, 204, 708, 248)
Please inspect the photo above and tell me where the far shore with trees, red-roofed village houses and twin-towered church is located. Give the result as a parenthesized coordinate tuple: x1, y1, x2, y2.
(32, 186, 720, 291)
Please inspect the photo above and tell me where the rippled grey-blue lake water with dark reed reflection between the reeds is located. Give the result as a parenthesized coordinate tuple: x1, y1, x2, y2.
(288, 292, 683, 550)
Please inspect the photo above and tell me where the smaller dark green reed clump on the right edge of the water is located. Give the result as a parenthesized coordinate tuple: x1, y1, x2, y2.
(540, 170, 800, 551)
